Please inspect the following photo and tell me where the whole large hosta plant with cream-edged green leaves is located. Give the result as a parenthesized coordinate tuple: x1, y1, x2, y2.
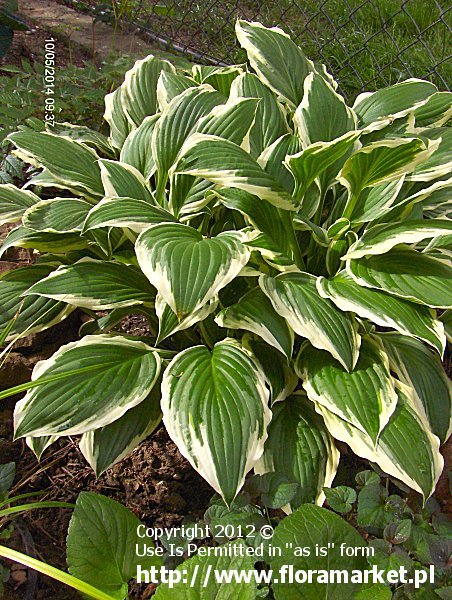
(0, 21, 452, 512)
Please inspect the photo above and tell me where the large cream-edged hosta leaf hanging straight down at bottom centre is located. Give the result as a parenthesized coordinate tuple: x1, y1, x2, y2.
(162, 339, 271, 505)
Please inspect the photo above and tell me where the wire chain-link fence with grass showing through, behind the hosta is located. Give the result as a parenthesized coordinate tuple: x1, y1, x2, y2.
(112, 0, 452, 96)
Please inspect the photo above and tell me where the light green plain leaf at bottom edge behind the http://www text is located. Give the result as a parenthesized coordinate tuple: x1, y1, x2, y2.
(155, 540, 257, 600)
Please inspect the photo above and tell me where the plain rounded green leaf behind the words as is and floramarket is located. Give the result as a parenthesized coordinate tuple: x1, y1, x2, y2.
(270, 504, 367, 600)
